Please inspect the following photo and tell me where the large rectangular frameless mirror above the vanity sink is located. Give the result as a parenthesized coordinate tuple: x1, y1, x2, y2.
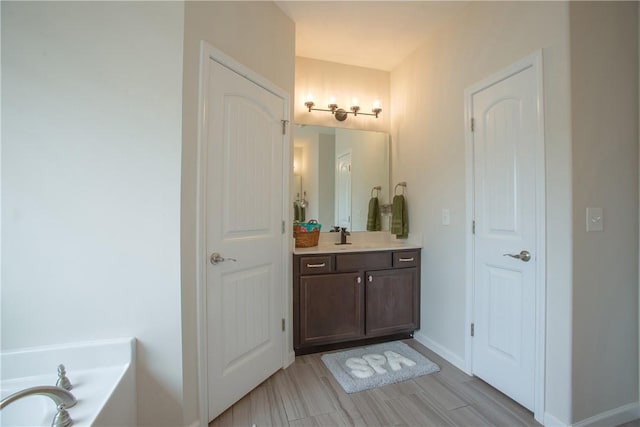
(291, 125, 391, 231)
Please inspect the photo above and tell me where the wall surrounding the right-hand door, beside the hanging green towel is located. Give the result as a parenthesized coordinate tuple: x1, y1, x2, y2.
(391, 2, 572, 423)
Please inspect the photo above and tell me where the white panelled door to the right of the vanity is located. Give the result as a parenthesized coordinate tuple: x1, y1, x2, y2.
(472, 63, 538, 410)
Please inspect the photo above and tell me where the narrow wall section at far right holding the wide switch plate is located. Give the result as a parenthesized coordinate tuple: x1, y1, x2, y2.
(569, 2, 638, 421)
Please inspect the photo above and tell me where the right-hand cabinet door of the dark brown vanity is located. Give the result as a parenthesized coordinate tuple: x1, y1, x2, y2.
(366, 268, 419, 336)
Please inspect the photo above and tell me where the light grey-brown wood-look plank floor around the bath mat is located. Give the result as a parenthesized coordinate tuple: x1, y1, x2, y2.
(209, 340, 540, 427)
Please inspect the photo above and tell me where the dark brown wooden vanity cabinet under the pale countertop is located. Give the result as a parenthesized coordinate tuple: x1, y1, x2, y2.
(293, 249, 420, 354)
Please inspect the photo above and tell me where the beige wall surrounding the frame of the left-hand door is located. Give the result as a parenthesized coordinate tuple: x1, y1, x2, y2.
(181, 1, 295, 425)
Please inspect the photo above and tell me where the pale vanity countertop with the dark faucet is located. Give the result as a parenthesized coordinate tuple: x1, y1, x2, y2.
(293, 231, 420, 255)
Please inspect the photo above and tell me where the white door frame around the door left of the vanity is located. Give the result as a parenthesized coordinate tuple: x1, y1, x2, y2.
(195, 40, 292, 427)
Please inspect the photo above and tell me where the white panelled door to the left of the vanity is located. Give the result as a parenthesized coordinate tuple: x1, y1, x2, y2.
(203, 53, 286, 420)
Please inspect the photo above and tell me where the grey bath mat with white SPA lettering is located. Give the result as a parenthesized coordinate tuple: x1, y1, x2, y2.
(322, 341, 440, 393)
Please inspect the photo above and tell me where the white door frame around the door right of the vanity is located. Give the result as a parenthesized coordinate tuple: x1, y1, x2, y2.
(464, 50, 547, 423)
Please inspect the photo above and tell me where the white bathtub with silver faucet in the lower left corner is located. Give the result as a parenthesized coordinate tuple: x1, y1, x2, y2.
(0, 338, 137, 427)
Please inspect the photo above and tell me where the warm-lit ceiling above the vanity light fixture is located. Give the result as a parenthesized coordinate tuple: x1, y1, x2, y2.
(276, 1, 467, 71)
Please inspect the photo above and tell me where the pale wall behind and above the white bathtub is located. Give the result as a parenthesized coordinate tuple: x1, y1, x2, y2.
(2, 2, 183, 426)
